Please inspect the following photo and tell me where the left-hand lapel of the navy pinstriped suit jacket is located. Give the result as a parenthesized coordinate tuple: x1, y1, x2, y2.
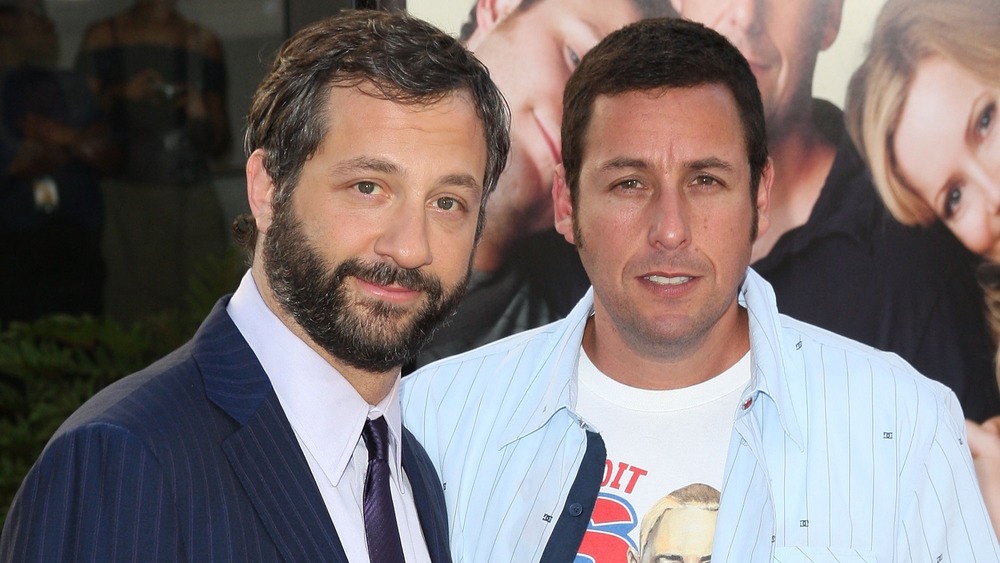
(193, 299, 348, 563)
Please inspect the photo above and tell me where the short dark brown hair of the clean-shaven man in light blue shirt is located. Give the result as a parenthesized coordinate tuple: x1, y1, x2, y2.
(562, 18, 767, 238)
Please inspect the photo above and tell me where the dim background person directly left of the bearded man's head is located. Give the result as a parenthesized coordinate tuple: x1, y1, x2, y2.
(76, 0, 229, 321)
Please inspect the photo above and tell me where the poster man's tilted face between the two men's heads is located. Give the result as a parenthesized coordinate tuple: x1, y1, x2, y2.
(466, 0, 640, 233)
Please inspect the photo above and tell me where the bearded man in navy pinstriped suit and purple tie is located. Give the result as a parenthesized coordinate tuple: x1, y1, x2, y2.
(0, 11, 509, 563)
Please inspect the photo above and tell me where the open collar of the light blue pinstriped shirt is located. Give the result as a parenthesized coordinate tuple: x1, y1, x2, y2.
(499, 268, 805, 448)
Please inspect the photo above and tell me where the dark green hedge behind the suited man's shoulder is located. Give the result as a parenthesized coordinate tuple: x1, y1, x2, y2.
(0, 250, 244, 527)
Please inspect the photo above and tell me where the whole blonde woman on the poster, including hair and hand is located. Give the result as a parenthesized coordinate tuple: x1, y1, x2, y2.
(847, 0, 1000, 533)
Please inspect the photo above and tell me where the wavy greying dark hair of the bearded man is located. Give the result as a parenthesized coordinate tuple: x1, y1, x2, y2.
(233, 10, 510, 252)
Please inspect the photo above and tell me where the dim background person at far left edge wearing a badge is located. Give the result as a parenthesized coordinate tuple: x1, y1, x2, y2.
(0, 0, 115, 325)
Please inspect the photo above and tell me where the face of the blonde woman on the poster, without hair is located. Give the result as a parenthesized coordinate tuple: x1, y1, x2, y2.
(893, 57, 1000, 262)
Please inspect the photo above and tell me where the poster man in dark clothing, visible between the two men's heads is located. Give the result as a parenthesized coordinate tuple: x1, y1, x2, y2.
(416, 0, 674, 366)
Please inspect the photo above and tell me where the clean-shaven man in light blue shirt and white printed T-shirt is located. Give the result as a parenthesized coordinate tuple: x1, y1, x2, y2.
(403, 19, 1000, 563)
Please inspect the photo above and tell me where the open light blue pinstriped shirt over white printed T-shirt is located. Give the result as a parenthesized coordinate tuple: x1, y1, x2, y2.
(402, 270, 1000, 563)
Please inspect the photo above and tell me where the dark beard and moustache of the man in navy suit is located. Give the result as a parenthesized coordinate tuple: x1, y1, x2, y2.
(262, 203, 471, 373)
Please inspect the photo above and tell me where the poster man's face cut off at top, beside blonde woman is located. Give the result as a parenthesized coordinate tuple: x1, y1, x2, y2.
(672, 0, 843, 137)
